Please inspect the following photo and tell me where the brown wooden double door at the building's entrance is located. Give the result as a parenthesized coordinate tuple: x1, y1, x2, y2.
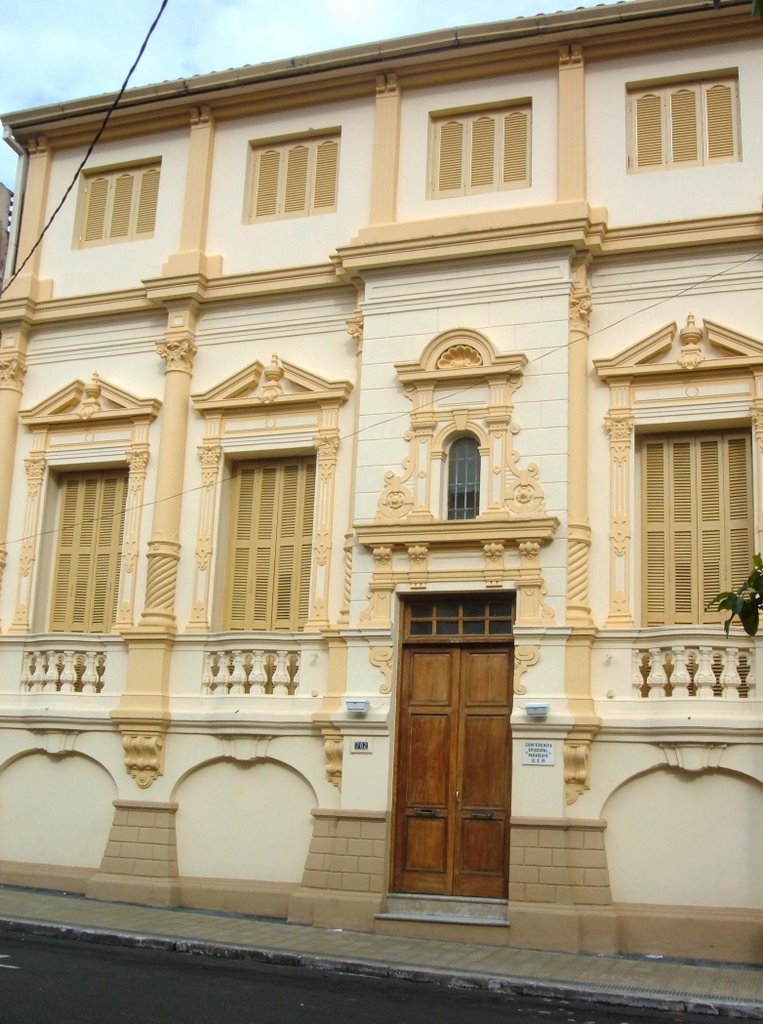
(392, 602, 513, 899)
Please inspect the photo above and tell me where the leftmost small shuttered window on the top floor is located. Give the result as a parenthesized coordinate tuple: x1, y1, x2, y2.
(79, 163, 160, 246)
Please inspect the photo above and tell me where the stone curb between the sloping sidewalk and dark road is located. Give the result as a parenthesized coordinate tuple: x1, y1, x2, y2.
(0, 918, 763, 1020)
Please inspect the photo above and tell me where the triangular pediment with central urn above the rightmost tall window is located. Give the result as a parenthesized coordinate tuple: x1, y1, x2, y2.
(594, 315, 763, 380)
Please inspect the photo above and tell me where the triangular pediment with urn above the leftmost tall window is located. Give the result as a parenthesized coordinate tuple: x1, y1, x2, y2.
(19, 374, 161, 427)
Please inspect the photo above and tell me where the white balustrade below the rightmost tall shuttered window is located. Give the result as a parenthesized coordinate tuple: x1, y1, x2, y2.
(632, 641, 755, 700)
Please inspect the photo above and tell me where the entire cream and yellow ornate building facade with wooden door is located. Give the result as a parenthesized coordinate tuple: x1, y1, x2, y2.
(0, 0, 763, 963)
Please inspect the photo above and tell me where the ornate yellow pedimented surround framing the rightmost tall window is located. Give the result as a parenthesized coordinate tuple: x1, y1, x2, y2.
(594, 314, 763, 629)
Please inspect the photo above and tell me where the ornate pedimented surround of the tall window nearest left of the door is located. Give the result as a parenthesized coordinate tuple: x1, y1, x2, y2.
(186, 355, 352, 633)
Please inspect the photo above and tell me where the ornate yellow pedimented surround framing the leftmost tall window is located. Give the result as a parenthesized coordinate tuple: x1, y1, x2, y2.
(13, 373, 161, 634)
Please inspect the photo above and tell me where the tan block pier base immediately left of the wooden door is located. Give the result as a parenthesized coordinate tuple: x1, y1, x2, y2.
(289, 808, 387, 931)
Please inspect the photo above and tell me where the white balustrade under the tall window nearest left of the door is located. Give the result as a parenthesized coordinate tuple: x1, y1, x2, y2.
(202, 645, 301, 696)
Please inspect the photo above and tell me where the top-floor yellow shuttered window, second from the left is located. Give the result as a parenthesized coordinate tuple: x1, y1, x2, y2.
(248, 133, 339, 220)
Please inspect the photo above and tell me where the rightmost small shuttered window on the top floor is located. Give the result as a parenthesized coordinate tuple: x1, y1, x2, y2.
(628, 78, 739, 171)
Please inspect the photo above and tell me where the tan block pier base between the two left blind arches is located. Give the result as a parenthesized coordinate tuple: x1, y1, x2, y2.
(86, 800, 179, 906)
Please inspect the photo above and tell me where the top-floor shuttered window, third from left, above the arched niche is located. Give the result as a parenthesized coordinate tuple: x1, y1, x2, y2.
(431, 103, 531, 199)
